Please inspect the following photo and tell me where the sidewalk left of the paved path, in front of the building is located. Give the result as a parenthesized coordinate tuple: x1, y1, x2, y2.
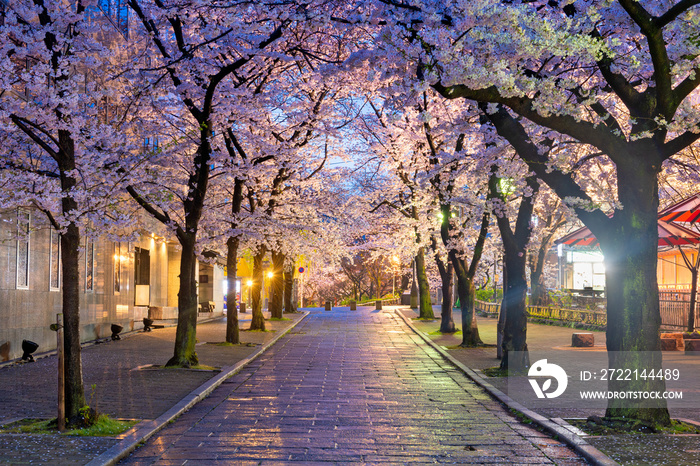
(0, 313, 305, 465)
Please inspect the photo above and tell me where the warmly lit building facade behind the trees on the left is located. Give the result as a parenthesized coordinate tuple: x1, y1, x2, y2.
(0, 209, 225, 362)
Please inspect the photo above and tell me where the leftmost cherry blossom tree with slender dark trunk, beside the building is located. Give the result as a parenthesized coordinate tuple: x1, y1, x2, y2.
(0, 0, 134, 425)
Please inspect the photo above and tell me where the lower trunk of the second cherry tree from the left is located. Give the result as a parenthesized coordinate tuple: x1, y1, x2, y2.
(165, 234, 199, 367)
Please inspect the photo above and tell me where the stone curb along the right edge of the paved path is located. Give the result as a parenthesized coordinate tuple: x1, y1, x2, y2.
(396, 309, 619, 466)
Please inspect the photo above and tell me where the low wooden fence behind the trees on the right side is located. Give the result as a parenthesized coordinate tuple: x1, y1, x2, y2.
(474, 291, 700, 331)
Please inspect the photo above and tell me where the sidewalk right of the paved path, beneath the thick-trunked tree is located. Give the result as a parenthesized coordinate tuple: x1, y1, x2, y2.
(401, 306, 700, 465)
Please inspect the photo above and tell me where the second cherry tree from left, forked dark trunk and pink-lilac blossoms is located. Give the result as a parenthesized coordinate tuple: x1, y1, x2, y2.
(128, 0, 294, 367)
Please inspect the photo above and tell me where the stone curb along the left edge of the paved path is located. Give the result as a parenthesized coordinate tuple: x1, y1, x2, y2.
(85, 311, 309, 466)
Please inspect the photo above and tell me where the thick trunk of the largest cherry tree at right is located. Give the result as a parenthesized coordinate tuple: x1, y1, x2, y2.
(593, 158, 670, 425)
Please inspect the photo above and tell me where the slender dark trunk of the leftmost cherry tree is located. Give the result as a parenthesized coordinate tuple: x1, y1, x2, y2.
(61, 222, 86, 425)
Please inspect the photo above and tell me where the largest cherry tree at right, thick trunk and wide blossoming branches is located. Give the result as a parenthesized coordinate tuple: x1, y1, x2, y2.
(366, 0, 700, 424)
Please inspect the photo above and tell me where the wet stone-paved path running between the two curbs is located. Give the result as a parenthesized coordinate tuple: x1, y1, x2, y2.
(122, 310, 585, 465)
